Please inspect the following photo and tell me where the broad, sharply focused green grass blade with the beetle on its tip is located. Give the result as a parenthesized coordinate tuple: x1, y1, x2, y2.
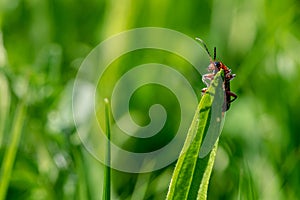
(167, 71, 224, 200)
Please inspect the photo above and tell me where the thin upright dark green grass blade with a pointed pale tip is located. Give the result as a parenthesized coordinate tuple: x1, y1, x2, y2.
(103, 98, 111, 200)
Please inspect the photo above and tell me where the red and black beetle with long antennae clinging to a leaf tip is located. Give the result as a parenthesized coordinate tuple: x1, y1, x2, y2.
(196, 38, 237, 112)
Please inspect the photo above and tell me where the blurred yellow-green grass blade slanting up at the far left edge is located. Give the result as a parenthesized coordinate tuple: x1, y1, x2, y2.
(0, 102, 26, 200)
